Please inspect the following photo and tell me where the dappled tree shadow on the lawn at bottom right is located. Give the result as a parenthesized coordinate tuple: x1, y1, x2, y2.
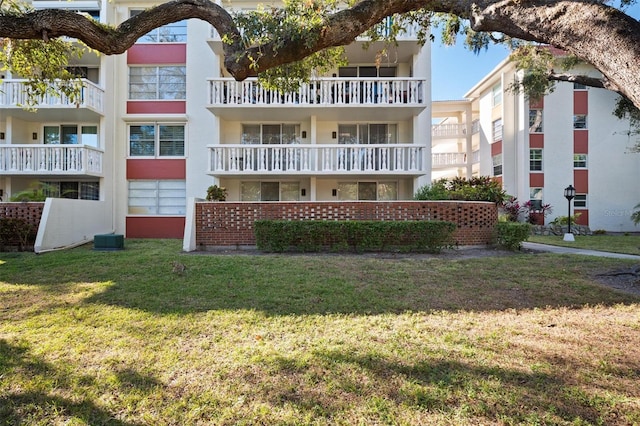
(262, 351, 640, 424)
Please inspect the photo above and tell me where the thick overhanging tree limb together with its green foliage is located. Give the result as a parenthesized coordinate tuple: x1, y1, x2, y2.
(0, 0, 640, 110)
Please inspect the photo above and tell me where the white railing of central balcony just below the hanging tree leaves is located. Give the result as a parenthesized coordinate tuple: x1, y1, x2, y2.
(209, 78, 427, 106)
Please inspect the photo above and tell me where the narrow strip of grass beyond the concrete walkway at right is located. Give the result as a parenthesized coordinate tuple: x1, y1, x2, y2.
(528, 235, 640, 255)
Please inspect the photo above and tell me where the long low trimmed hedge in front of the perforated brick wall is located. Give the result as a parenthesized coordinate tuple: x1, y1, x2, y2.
(254, 219, 456, 253)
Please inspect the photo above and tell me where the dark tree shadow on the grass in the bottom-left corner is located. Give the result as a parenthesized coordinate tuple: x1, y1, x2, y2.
(0, 339, 148, 426)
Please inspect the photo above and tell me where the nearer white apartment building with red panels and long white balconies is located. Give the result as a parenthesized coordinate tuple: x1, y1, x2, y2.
(0, 0, 431, 238)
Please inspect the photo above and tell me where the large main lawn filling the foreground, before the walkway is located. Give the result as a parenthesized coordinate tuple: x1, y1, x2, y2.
(0, 240, 640, 425)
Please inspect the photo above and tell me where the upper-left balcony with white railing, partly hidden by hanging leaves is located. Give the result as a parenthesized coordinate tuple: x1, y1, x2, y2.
(0, 79, 104, 121)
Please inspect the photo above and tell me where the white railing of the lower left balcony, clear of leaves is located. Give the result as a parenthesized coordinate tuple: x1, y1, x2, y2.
(0, 144, 102, 175)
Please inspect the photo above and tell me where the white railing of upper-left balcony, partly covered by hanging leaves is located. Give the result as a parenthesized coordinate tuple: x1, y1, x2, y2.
(0, 79, 104, 113)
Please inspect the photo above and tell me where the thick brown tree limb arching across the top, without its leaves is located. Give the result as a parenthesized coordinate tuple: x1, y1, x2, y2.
(0, 0, 640, 106)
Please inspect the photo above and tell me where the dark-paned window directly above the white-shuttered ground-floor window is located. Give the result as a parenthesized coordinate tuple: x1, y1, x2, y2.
(129, 124, 184, 157)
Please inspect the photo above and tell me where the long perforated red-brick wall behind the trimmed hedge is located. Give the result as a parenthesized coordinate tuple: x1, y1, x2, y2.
(195, 201, 498, 250)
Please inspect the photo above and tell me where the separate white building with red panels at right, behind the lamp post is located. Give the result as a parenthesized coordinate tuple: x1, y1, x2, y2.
(433, 56, 640, 232)
